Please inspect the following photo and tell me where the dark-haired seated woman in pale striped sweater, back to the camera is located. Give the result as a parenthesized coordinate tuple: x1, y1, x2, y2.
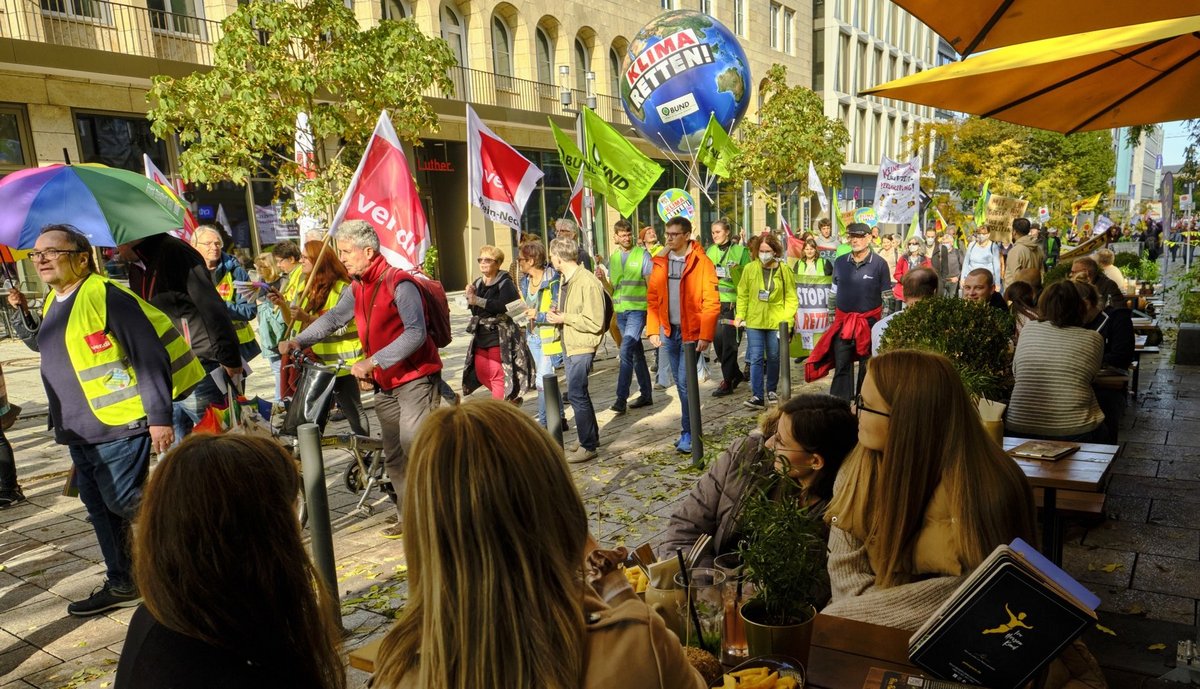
(1004, 280, 1104, 442)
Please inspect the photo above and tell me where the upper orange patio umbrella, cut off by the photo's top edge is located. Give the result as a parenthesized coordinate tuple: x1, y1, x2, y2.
(892, 0, 1200, 58)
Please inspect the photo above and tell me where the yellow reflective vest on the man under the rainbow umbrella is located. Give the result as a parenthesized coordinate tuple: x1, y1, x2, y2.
(42, 274, 204, 426)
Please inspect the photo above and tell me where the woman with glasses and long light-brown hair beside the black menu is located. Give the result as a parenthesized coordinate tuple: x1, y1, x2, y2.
(822, 349, 1036, 630)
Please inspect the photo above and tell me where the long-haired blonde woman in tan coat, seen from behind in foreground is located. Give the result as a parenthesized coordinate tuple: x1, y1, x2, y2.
(373, 400, 704, 689)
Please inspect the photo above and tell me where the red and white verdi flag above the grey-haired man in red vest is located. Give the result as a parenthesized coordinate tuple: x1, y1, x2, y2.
(330, 110, 430, 270)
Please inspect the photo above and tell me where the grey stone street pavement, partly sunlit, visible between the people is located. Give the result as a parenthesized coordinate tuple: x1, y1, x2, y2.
(0, 298, 1200, 689)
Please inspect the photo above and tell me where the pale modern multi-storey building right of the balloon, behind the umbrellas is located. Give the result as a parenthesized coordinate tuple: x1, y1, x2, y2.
(812, 0, 955, 218)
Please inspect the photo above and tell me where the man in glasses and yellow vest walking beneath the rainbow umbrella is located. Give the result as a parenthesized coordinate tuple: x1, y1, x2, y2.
(8, 224, 204, 617)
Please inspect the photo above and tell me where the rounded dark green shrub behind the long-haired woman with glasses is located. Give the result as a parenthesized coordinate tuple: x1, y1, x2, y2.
(880, 298, 1015, 400)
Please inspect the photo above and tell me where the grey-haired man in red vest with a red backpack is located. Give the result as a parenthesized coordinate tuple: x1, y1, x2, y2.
(280, 220, 442, 539)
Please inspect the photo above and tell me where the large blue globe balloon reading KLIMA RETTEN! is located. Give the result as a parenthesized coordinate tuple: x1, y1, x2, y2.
(620, 10, 751, 155)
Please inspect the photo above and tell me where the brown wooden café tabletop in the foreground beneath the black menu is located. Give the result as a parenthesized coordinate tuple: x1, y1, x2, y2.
(805, 615, 920, 689)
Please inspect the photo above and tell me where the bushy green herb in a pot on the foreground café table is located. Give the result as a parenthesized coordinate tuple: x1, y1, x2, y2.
(738, 472, 828, 664)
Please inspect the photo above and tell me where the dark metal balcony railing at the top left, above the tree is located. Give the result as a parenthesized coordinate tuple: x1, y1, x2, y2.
(0, 0, 221, 65)
